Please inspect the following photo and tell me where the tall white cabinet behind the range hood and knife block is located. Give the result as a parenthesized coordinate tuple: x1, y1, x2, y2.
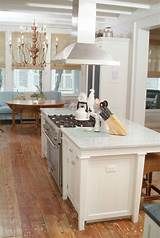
(97, 37, 129, 117)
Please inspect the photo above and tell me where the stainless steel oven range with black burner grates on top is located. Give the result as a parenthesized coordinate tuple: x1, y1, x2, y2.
(43, 111, 95, 192)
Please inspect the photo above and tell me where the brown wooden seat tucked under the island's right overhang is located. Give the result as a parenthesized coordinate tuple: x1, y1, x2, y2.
(142, 153, 160, 200)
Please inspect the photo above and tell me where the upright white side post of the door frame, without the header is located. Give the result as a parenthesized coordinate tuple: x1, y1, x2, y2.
(130, 26, 149, 124)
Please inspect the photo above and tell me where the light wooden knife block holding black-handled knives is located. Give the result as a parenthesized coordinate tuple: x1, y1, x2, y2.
(100, 101, 127, 136)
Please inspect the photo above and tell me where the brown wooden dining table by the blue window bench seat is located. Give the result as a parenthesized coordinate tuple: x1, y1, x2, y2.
(6, 100, 64, 128)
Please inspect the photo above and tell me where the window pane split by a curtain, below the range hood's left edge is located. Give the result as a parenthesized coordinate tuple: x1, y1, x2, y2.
(51, 70, 80, 95)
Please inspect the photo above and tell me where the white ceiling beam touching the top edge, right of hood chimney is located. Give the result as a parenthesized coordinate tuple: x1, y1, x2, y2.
(96, 0, 151, 9)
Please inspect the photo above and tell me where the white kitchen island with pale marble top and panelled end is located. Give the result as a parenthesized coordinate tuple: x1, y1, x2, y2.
(40, 109, 160, 230)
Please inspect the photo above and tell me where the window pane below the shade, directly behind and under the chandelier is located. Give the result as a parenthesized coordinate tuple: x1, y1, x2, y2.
(14, 69, 40, 92)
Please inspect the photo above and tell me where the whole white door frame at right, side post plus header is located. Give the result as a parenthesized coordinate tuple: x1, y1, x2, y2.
(129, 9, 160, 125)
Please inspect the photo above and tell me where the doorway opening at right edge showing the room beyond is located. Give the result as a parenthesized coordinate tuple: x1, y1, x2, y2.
(145, 27, 160, 131)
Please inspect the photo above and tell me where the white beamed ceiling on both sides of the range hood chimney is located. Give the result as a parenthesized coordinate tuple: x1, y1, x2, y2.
(0, 0, 160, 27)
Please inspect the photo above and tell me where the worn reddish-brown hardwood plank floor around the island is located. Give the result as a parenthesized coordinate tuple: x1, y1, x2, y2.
(0, 125, 144, 238)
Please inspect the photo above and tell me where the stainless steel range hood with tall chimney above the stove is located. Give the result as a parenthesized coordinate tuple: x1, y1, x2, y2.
(53, 0, 120, 65)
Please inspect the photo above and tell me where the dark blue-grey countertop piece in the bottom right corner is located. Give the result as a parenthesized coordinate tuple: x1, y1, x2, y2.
(144, 203, 160, 226)
